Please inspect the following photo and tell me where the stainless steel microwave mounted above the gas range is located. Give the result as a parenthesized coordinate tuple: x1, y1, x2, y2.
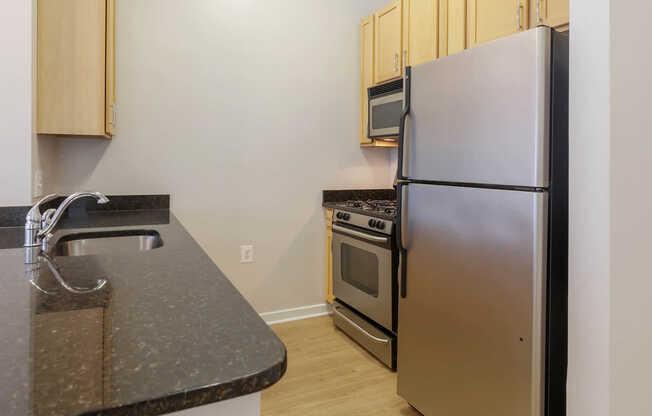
(367, 79, 403, 140)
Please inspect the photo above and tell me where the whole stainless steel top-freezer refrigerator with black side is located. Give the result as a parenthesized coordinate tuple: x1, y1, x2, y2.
(397, 27, 568, 416)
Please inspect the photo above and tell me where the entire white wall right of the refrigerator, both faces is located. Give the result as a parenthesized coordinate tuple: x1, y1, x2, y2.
(568, 0, 652, 416)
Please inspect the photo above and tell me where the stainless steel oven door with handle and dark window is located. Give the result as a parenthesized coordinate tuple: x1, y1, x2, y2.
(332, 224, 392, 330)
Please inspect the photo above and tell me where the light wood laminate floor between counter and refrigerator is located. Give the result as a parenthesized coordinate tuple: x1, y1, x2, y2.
(262, 316, 419, 416)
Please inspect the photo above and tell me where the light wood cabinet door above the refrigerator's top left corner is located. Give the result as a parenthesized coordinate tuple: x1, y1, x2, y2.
(404, 0, 439, 65)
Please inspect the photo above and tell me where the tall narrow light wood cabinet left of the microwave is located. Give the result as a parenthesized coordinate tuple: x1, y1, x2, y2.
(360, 15, 374, 144)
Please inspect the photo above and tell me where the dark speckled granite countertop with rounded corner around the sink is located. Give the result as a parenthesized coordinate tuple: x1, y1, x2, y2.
(0, 200, 287, 416)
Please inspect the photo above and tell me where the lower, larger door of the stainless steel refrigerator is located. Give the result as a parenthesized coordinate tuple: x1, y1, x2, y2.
(397, 184, 548, 416)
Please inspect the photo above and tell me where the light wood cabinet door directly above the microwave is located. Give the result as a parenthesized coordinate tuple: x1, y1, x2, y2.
(374, 0, 402, 83)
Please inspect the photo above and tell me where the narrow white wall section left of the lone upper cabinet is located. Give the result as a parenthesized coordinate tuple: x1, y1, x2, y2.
(0, 1, 32, 206)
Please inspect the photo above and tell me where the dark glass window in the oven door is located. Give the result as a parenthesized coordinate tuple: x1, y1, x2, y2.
(340, 243, 379, 298)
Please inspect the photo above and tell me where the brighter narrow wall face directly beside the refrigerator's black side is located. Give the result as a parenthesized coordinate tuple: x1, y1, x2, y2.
(568, 0, 610, 416)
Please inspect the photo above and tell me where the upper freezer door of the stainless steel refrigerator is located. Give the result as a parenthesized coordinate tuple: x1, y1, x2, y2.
(404, 27, 551, 187)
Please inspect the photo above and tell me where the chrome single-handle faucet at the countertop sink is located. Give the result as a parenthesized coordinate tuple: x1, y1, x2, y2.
(25, 192, 109, 264)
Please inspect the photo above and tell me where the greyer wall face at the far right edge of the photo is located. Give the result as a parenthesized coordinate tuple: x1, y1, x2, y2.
(610, 0, 652, 416)
